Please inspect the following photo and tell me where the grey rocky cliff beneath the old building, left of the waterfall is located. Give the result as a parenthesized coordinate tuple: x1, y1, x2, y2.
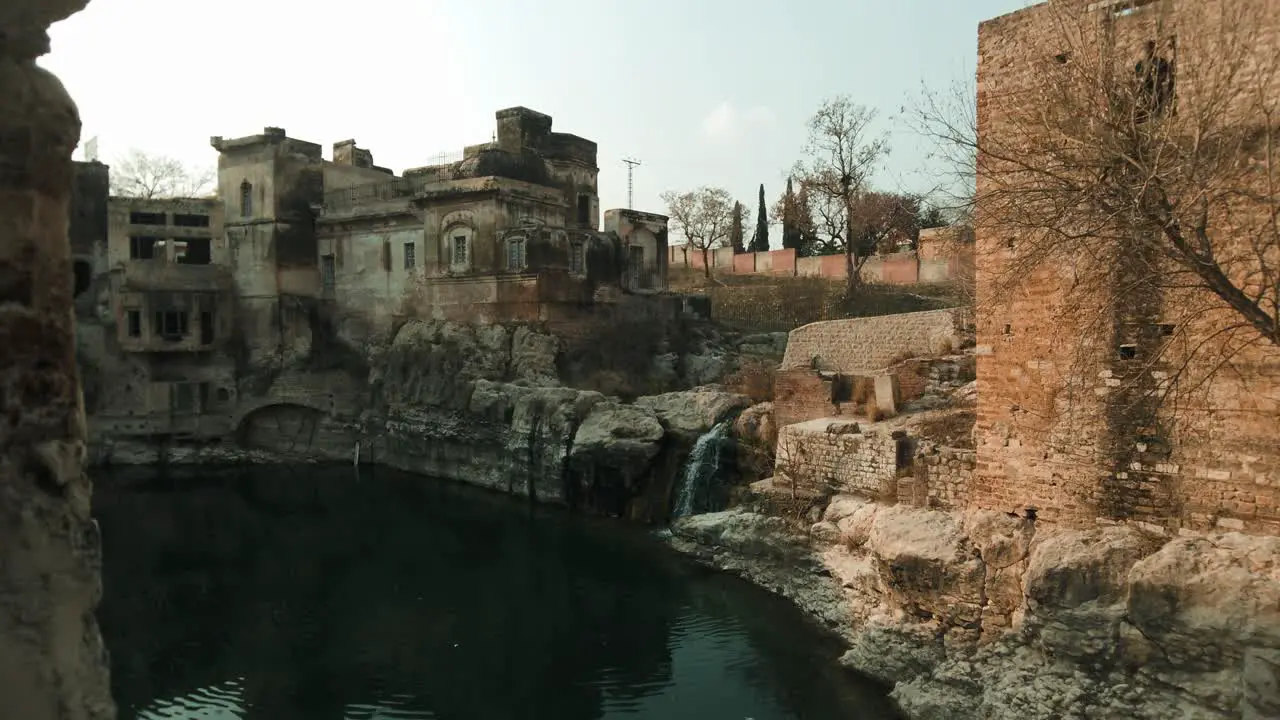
(93, 320, 786, 521)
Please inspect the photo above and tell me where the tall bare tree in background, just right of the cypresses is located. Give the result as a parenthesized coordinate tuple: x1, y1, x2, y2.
(795, 95, 888, 291)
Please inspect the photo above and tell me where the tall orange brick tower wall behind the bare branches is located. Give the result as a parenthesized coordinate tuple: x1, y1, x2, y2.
(970, 0, 1280, 533)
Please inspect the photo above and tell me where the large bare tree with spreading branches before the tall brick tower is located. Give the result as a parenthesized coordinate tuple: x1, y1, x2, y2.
(918, 0, 1280, 445)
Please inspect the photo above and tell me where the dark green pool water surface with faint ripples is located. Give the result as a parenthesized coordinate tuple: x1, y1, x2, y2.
(95, 468, 893, 720)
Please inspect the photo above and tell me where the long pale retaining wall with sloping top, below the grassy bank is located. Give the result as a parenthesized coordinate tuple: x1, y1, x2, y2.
(782, 310, 960, 373)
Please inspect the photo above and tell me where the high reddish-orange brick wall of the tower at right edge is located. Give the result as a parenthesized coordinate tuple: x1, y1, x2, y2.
(968, 0, 1280, 533)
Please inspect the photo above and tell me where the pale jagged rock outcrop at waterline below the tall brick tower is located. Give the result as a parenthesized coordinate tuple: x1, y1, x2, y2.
(673, 497, 1280, 720)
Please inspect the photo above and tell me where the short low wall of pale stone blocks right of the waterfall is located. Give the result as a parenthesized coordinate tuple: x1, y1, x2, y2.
(774, 420, 899, 498)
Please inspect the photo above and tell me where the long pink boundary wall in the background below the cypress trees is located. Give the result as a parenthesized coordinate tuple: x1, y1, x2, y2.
(667, 228, 973, 284)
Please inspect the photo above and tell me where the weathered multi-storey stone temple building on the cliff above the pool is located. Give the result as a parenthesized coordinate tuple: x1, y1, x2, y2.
(70, 108, 678, 445)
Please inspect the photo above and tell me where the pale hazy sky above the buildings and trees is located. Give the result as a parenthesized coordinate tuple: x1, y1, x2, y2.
(41, 0, 1030, 235)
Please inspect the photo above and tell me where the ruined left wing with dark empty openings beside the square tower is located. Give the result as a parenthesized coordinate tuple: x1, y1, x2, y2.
(70, 183, 237, 439)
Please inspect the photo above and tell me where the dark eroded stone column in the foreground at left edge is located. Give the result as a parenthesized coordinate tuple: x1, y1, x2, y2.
(0, 0, 115, 720)
